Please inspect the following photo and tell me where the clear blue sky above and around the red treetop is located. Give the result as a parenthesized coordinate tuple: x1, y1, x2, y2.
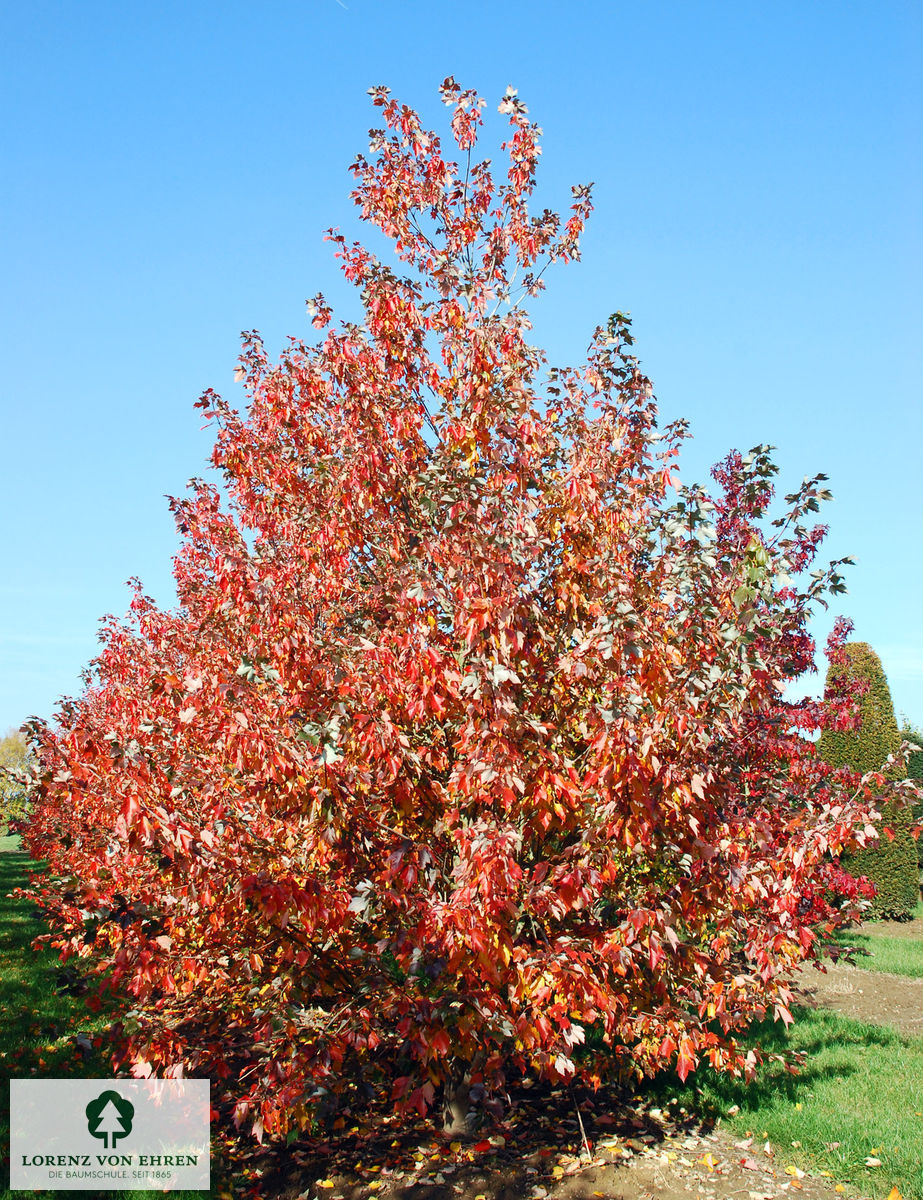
(0, 0, 923, 731)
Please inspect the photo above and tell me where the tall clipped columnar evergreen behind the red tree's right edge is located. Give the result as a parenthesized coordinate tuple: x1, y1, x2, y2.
(819, 642, 919, 920)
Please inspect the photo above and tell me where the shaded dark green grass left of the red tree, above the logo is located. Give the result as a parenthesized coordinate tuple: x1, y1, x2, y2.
(0, 836, 216, 1200)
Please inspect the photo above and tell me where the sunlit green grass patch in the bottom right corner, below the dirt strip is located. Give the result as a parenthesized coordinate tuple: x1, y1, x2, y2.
(652, 1009, 923, 1200)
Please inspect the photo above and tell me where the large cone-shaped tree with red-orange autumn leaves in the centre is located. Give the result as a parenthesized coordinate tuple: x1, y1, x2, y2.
(28, 79, 902, 1136)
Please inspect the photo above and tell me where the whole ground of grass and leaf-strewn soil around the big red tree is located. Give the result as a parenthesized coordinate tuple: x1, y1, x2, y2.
(0, 839, 923, 1200)
